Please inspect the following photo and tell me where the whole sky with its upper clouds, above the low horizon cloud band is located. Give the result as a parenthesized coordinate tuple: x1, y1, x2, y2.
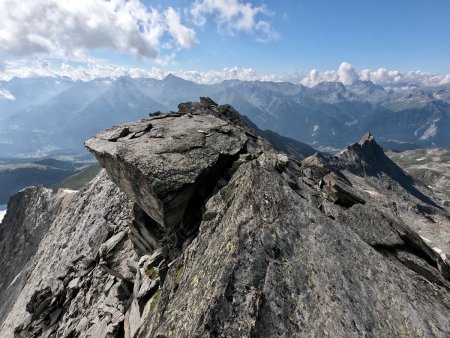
(0, 0, 450, 84)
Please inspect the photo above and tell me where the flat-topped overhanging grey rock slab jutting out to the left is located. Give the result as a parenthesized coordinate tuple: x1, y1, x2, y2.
(86, 106, 247, 248)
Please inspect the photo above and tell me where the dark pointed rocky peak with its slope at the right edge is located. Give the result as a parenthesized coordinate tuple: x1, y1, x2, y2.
(322, 133, 450, 266)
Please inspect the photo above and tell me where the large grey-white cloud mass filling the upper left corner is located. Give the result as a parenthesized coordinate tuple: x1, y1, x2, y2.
(0, 0, 196, 58)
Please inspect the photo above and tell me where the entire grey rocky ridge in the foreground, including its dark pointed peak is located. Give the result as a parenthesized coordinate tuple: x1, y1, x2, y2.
(0, 98, 450, 337)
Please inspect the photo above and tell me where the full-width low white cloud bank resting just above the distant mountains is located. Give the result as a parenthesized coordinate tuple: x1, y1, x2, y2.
(0, 58, 450, 89)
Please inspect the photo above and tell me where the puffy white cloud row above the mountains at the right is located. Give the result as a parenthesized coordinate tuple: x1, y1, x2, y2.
(300, 62, 450, 88)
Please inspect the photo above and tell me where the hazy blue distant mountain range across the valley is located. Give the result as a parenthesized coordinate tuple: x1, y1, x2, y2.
(0, 75, 450, 157)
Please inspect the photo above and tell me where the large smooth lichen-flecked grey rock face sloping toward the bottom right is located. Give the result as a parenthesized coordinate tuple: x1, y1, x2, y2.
(138, 154, 449, 337)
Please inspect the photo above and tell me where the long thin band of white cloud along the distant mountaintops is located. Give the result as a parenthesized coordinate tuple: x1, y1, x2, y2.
(0, 61, 450, 89)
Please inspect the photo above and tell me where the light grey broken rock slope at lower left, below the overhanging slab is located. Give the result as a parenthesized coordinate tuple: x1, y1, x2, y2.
(0, 172, 137, 337)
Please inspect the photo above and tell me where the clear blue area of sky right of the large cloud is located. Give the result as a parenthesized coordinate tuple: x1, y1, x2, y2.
(99, 0, 450, 73)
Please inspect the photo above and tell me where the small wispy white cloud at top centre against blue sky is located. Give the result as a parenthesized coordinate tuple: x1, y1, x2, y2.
(191, 0, 278, 42)
